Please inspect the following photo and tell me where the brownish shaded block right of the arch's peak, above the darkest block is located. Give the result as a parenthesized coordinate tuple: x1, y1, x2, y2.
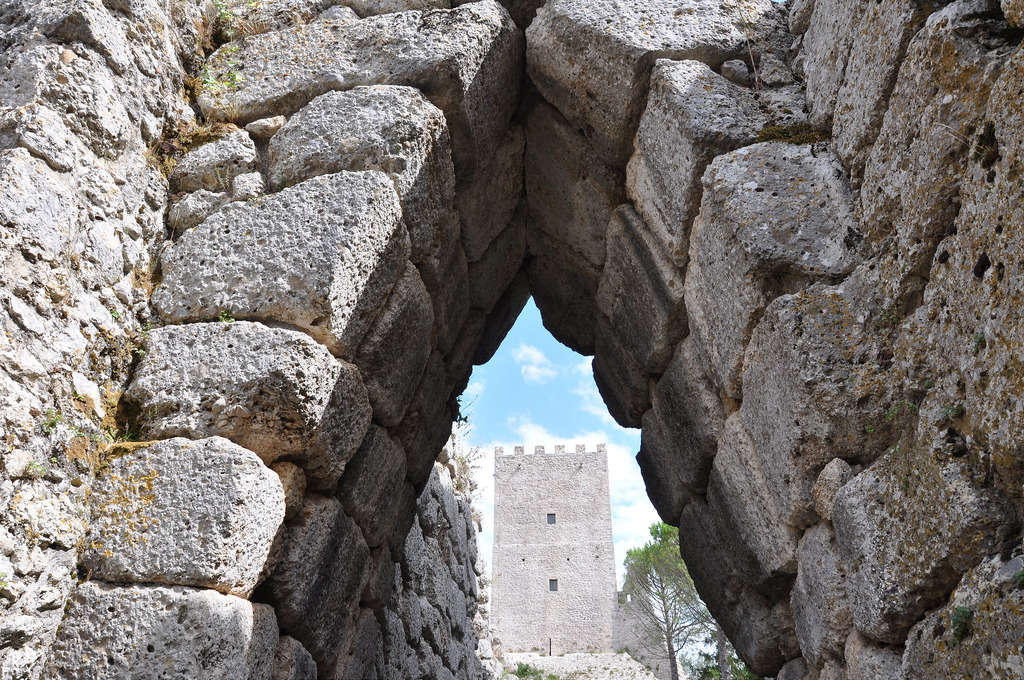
(524, 102, 626, 267)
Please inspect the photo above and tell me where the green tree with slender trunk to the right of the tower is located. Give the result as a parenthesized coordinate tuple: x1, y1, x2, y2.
(624, 522, 748, 680)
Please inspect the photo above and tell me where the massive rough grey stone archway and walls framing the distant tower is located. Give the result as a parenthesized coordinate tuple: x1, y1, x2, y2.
(6, 0, 1024, 680)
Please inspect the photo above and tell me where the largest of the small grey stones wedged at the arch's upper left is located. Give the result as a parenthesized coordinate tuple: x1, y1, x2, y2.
(170, 130, 256, 192)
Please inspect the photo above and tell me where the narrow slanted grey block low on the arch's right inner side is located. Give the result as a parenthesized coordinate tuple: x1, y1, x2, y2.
(713, 413, 799, 576)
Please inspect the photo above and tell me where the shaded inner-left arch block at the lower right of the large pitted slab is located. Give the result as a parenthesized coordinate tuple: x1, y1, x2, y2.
(353, 264, 434, 427)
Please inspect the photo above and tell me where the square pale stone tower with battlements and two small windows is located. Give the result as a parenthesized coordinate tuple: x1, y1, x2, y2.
(492, 444, 615, 654)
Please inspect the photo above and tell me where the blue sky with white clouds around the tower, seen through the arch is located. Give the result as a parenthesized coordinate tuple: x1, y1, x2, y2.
(462, 299, 657, 585)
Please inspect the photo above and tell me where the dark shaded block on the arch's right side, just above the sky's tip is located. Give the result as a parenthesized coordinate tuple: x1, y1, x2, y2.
(528, 229, 600, 356)
